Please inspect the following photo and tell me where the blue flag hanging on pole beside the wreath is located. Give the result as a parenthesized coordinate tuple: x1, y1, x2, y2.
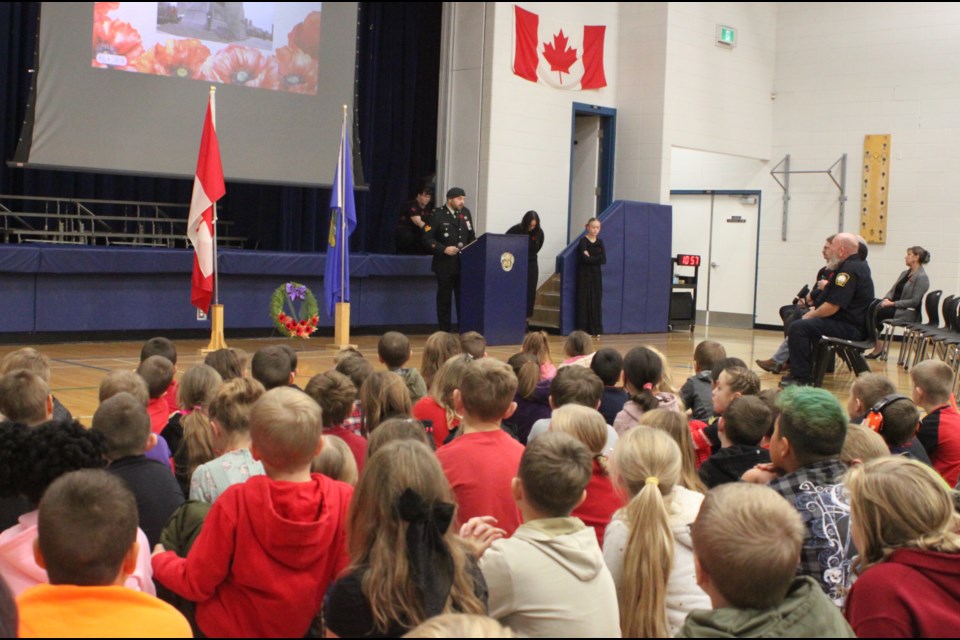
(323, 120, 357, 318)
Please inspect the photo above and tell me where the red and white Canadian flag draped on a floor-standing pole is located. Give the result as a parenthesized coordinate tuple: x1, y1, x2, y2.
(187, 91, 226, 313)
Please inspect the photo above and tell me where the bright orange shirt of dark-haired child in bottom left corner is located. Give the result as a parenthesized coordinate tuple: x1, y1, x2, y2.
(17, 584, 193, 638)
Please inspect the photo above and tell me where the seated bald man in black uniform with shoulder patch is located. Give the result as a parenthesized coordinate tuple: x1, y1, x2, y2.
(780, 233, 874, 386)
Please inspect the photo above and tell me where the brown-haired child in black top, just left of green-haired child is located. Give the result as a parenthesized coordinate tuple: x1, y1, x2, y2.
(699, 396, 770, 489)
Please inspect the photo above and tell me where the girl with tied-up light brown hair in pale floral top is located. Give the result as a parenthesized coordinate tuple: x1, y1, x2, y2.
(184, 372, 266, 503)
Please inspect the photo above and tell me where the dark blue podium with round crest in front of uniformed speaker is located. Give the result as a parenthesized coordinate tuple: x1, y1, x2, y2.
(458, 233, 530, 346)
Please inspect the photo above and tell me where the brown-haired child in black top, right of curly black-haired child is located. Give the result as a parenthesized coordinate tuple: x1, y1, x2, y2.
(92, 393, 184, 545)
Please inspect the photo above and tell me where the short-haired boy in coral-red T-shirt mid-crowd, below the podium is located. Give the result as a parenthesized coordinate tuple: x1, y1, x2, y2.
(437, 358, 523, 535)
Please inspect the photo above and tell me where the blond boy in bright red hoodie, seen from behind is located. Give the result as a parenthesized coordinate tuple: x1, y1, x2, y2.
(153, 387, 353, 637)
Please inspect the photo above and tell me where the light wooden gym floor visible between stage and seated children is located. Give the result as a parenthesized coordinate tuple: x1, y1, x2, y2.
(0, 327, 910, 424)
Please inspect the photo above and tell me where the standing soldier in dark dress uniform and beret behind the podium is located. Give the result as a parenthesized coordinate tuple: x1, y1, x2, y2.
(423, 187, 477, 331)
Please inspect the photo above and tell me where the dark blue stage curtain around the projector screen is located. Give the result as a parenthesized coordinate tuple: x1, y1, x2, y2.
(0, 2, 442, 253)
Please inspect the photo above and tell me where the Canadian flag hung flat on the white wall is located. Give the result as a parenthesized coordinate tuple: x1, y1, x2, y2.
(513, 5, 607, 90)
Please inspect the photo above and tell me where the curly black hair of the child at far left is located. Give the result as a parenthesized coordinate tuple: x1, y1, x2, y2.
(11, 420, 107, 505)
